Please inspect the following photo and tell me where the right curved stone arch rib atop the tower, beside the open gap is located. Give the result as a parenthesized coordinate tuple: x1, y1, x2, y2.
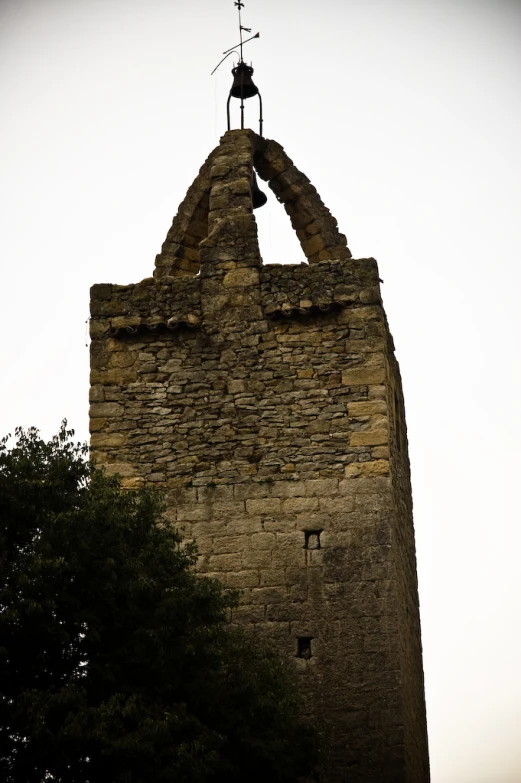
(254, 138, 351, 264)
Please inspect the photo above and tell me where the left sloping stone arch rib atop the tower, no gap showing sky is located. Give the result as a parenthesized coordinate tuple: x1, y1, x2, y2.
(154, 146, 220, 278)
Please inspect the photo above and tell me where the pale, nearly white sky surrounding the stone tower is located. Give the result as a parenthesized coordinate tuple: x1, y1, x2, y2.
(0, 0, 521, 783)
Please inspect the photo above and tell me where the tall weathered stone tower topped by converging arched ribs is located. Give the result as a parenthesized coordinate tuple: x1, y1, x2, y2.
(91, 130, 429, 783)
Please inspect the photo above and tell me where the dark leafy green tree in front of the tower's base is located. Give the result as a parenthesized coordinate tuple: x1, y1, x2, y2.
(0, 425, 316, 783)
